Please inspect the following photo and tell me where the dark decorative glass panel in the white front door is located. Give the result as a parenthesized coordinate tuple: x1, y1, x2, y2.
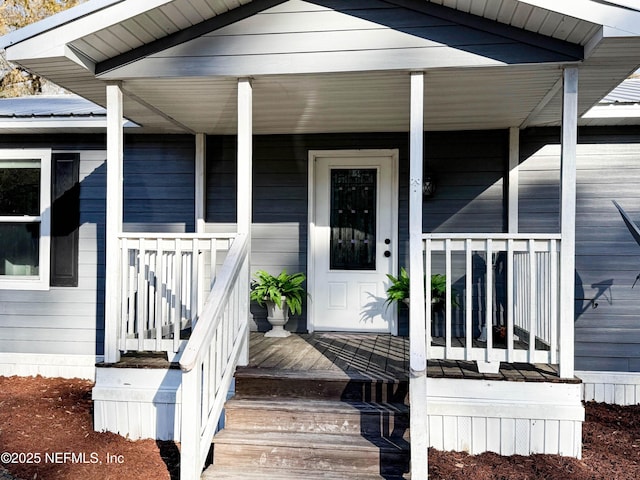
(329, 168, 378, 270)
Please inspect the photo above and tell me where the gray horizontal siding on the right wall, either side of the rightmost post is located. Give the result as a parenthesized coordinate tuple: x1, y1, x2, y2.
(520, 127, 640, 371)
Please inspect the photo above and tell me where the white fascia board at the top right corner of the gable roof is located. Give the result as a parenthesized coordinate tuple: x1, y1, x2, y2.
(519, 0, 640, 36)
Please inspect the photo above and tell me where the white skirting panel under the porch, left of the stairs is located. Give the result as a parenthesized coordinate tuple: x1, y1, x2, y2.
(92, 368, 182, 441)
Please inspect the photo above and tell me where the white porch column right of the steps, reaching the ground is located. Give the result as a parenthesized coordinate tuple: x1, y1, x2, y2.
(409, 72, 429, 479)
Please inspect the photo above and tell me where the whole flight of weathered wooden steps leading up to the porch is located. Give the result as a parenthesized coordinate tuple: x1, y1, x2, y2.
(202, 368, 409, 480)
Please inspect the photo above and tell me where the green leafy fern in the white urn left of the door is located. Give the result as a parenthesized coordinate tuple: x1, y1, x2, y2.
(250, 270, 307, 315)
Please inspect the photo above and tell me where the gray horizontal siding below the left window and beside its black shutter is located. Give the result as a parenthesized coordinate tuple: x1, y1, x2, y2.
(0, 150, 106, 355)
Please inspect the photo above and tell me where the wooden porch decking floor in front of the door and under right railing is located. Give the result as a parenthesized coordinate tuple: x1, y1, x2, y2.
(248, 332, 580, 383)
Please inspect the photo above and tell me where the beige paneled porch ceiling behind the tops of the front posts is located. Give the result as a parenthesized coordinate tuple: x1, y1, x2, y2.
(115, 66, 561, 134)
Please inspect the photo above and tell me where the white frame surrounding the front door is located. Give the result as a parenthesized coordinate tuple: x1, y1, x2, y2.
(307, 149, 399, 335)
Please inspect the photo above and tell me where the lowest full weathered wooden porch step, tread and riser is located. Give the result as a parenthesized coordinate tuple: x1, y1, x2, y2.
(214, 429, 408, 478)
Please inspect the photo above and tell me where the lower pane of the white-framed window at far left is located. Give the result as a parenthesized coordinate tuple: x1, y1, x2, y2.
(0, 223, 40, 276)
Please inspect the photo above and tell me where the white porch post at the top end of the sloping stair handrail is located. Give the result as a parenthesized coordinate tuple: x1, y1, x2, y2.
(237, 78, 253, 365)
